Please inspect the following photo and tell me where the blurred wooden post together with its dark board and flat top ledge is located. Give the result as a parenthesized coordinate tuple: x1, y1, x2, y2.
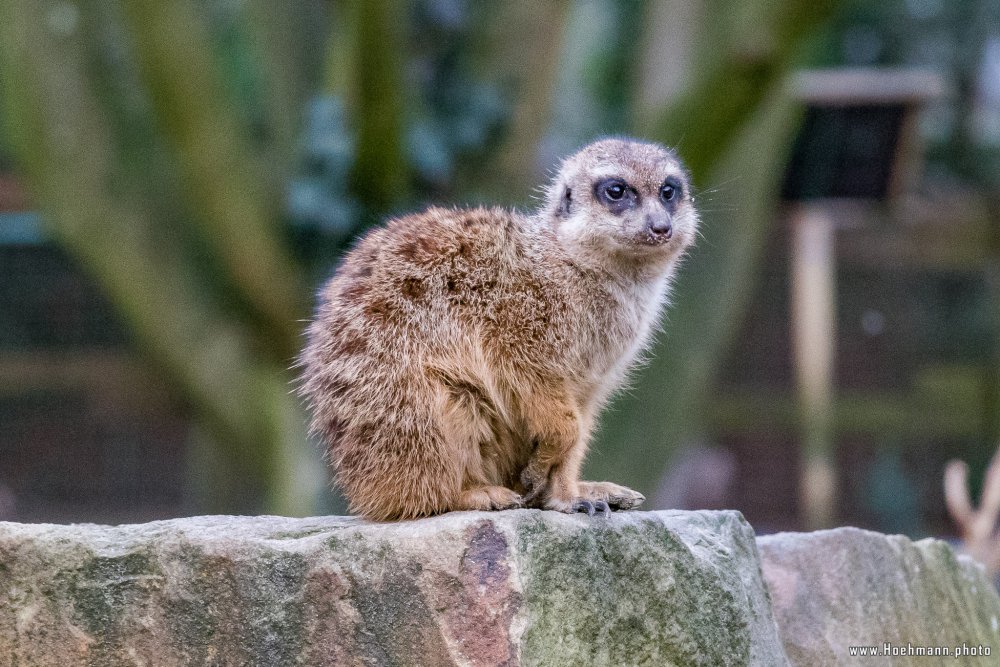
(784, 69, 944, 530)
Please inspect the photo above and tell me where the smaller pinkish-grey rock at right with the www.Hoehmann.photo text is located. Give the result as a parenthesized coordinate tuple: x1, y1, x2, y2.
(757, 528, 1000, 666)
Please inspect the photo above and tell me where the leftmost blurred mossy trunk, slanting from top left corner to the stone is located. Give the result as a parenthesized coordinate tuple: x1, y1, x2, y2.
(0, 0, 318, 514)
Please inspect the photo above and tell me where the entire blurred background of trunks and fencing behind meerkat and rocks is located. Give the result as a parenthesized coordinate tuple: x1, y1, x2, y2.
(0, 0, 1000, 552)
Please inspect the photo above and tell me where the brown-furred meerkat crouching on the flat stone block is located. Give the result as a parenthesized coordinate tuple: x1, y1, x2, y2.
(300, 139, 698, 521)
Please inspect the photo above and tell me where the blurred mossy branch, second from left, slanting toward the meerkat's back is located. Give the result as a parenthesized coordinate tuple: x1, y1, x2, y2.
(124, 0, 307, 360)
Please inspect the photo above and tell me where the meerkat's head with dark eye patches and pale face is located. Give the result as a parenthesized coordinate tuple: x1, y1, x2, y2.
(545, 139, 698, 259)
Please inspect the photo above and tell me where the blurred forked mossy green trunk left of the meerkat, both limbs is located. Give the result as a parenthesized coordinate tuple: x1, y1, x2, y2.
(0, 0, 322, 514)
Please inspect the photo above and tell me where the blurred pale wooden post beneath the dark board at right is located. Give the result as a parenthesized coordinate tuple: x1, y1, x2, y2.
(791, 204, 837, 530)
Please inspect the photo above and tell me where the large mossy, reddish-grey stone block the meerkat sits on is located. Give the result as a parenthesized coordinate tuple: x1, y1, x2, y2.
(0, 510, 786, 667)
